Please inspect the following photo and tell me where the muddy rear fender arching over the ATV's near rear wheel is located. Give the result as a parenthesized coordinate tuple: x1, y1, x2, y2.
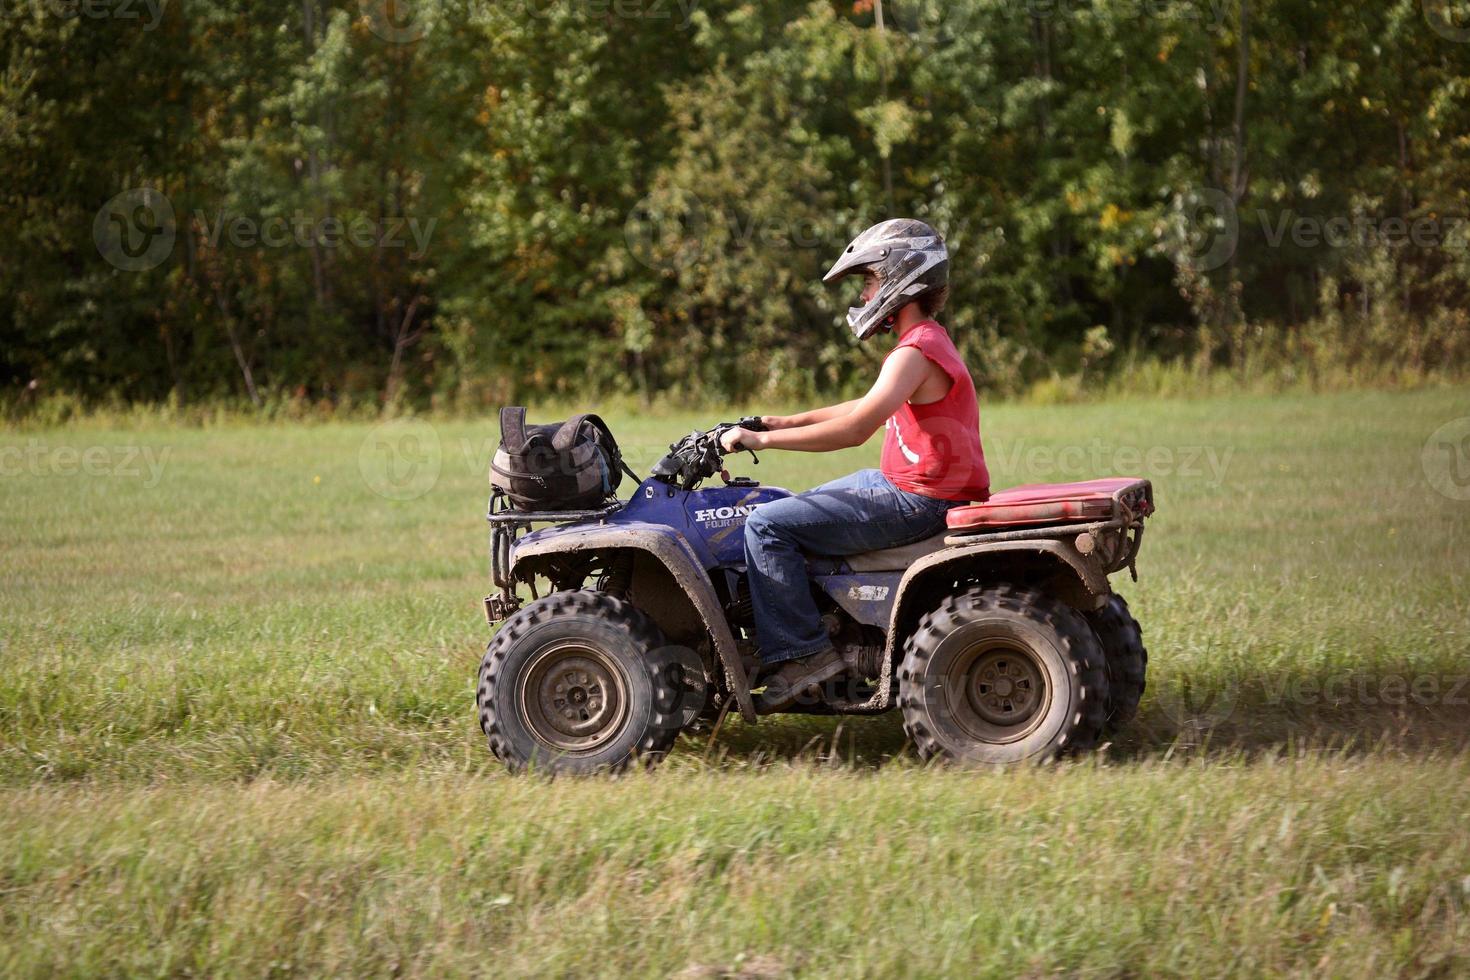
(888, 539, 1113, 678)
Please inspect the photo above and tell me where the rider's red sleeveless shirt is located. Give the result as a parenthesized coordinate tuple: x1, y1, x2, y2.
(879, 320, 991, 501)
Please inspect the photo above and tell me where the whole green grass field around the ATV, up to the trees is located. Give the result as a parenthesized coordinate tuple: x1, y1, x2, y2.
(0, 388, 1470, 977)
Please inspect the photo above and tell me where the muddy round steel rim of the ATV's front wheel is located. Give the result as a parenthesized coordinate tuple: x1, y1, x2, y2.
(519, 641, 628, 754)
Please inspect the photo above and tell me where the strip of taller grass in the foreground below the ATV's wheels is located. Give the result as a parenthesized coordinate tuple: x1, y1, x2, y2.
(0, 754, 1470, 977)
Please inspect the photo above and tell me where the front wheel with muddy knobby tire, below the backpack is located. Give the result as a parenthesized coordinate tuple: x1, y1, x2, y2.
(475, 589, 684, 773)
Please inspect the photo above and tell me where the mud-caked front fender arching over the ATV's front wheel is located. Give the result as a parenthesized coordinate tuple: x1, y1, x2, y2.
(510, 523, 756, 724)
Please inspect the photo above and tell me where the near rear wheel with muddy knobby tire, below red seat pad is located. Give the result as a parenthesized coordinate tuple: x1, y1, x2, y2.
(898, 585, 1108, 765)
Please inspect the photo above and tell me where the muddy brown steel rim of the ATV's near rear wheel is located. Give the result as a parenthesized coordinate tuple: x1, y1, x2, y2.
(944, 638, 1051, 743)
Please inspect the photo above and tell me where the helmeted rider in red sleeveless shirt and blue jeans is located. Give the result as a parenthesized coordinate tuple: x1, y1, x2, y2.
(722, 217, 989, 711)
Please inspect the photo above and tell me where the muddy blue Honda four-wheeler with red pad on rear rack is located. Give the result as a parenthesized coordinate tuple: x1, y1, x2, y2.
(476, 419, 1154, 773)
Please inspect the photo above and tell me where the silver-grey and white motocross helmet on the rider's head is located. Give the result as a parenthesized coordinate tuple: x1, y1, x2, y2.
(822, 217, 950, 341)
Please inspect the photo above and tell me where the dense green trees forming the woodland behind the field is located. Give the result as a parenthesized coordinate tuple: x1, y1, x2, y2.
(0, 0, 1470, 407)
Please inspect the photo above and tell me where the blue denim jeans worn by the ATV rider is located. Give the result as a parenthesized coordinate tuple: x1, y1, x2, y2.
(745, 470, 960, 664)
